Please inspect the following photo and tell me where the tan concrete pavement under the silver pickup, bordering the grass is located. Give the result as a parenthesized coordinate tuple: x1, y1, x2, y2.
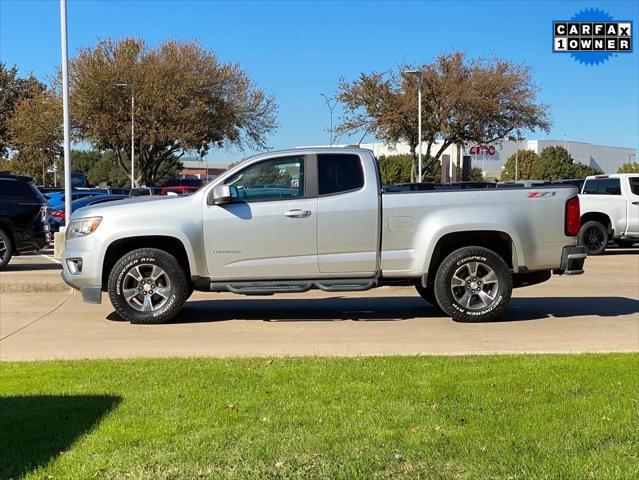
(0, 249, 639, 360)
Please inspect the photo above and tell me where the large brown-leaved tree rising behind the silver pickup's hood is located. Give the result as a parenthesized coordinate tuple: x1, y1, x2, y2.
(70, 38, 276, 185)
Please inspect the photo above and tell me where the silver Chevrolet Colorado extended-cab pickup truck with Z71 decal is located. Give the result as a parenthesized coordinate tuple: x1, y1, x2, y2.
(62, 148, 586, 323)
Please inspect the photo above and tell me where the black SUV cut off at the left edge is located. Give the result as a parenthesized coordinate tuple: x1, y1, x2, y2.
(0, 172, 49, 269)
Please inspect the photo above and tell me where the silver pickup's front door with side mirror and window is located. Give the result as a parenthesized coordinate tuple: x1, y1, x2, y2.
(203, 155, 318, 280)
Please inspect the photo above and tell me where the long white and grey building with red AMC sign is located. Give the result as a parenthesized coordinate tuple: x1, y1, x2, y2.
(361, 140, 637, 178)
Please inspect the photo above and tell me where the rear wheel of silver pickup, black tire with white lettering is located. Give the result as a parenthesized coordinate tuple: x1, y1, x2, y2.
(435, 247, 513, 323)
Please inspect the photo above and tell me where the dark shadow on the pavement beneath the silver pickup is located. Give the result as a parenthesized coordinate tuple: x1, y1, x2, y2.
(107, 297, 639, 324)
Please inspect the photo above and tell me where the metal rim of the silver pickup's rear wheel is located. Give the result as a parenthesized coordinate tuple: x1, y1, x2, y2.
(450, 262, 499, 310)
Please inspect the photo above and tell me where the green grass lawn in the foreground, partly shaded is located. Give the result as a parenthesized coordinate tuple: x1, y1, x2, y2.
(0, 354, 639, 479)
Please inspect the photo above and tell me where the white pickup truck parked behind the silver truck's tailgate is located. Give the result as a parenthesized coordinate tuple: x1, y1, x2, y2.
(579, 173, 639, 255)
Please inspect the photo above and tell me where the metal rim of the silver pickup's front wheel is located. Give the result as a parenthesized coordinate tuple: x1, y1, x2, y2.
(122, 264, 171, 313)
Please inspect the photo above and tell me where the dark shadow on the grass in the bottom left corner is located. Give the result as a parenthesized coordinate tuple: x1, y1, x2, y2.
(0, 395, 120, 478)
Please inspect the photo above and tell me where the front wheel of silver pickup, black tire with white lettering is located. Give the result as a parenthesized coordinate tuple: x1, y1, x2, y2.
(108, 248, 189, 324)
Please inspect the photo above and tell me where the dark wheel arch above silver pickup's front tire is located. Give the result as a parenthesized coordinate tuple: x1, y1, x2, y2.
(102, 235, 191, 291)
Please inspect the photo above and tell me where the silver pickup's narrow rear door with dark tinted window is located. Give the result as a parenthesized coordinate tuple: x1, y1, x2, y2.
(316, 153, 381, 276)
